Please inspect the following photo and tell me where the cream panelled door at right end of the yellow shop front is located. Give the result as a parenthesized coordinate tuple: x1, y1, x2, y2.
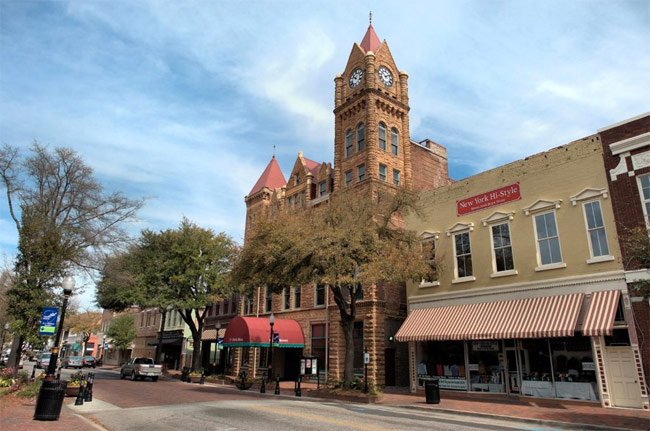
(605, 346, 641, 408)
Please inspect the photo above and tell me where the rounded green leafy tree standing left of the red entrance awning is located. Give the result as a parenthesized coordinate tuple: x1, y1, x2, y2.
(97, 218, 237, 369)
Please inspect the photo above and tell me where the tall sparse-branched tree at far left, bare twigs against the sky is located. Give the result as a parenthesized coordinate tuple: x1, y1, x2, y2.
(0, 143, 142, 365)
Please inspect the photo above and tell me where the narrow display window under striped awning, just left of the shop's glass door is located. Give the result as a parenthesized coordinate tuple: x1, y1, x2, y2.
(468, 340, 505, 392)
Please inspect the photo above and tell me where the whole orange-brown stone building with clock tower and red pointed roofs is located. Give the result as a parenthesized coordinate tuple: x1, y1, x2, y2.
(232, 25, 450, 385)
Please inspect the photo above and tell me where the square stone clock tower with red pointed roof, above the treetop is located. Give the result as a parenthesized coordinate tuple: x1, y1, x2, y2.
(334, 23, 412, 190)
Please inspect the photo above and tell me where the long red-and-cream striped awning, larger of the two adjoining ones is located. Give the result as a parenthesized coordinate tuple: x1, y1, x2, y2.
(395, 293, 584, 341)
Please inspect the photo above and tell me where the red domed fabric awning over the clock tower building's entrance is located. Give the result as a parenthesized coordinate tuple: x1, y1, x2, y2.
(223, 316, 305, 348)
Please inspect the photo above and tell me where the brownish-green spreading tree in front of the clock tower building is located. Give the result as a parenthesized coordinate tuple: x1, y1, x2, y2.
(232, 191, 432, 383)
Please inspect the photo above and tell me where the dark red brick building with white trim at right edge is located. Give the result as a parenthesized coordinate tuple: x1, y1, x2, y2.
(598, 113, 650, 402)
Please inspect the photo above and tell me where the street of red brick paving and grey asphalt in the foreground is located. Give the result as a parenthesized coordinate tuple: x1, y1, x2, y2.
(67, 370, 551, 431)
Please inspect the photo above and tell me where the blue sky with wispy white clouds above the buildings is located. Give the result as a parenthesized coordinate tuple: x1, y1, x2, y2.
(0, 0, 650, 307)
